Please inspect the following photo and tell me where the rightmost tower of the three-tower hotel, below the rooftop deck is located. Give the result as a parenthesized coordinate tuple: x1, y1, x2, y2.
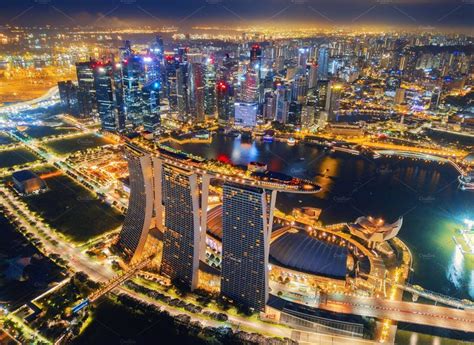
(221, 183, 276, 311)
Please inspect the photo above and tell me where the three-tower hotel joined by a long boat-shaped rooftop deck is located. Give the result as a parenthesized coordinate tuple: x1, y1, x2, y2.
(119, 145, 319, 311)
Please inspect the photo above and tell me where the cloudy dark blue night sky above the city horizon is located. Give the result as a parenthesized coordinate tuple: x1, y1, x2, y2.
(0, 0, 474, 31)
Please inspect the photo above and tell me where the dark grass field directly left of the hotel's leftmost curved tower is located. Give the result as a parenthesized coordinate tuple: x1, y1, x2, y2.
(24, 170, 123, 242)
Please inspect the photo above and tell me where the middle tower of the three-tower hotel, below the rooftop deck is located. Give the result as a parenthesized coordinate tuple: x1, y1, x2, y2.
(161, 165, 200, 289)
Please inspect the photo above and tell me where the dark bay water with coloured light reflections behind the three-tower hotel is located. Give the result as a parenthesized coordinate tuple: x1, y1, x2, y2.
(171, 134, 474, 298)
